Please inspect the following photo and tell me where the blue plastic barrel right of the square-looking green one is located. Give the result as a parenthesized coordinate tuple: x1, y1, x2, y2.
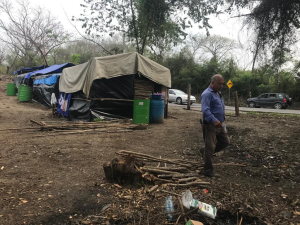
(150, 99, 165, 123)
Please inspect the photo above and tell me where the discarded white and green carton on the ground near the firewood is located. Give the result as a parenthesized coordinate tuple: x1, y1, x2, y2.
(182, 190, 217, 219)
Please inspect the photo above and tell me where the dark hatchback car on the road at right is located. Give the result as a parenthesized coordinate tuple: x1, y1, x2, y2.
(247, 93, 292, 109)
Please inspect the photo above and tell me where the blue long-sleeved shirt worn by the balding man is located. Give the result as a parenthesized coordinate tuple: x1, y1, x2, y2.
(201, 86, 225, 123)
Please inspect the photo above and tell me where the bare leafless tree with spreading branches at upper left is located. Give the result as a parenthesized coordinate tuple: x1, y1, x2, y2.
(0, 0, 69, 66)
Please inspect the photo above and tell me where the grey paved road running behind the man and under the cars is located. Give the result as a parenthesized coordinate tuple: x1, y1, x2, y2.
(169, 103, 300, 115)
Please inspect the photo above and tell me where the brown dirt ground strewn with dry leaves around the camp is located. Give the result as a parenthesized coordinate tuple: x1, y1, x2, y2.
(0, 76, 300, 225)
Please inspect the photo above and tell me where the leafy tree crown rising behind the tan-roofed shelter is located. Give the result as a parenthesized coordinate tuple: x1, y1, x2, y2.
(78, 0, 222, 54)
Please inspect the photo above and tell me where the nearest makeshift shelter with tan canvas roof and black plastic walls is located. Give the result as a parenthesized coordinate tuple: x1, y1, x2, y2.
(59, 53, 171, 121)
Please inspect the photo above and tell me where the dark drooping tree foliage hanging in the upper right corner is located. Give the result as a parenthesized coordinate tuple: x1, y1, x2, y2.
(224, 0, 300, 70)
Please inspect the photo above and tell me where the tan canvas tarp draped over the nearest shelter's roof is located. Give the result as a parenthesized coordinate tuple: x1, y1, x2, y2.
(59, 53, 171, 96)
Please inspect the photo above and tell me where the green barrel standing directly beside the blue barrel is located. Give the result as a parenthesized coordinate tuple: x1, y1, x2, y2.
(133, 99, 150, 124)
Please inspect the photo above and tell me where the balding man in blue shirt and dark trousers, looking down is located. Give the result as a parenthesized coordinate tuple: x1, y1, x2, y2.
(200, 74, 229, 177)
